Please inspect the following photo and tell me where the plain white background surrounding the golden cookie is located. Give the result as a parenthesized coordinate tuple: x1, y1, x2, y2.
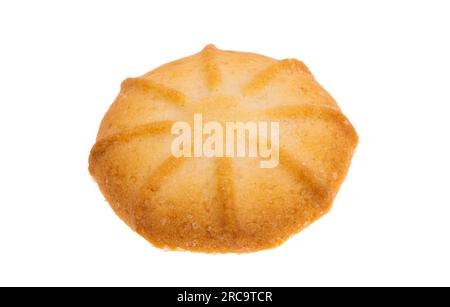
(0, 0, 450, 286)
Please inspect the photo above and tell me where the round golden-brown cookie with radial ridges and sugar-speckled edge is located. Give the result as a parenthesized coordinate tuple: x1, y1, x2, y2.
(89, 45, 358, 253)
